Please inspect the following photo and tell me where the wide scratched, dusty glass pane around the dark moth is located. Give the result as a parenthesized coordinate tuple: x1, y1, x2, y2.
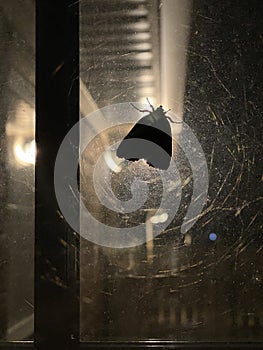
(80, 0, 263, 342)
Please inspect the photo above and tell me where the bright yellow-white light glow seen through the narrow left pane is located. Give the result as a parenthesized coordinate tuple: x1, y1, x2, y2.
(14, 140, 36, 165)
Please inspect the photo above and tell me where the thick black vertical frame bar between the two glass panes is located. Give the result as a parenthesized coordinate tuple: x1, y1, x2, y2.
(35, 0, 79, 350)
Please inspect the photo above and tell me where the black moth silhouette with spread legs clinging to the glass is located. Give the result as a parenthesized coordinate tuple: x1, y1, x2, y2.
(117, 99, 182, 170)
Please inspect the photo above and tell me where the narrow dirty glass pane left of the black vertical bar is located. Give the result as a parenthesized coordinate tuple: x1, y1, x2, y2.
(0, 0, 35, 341)
